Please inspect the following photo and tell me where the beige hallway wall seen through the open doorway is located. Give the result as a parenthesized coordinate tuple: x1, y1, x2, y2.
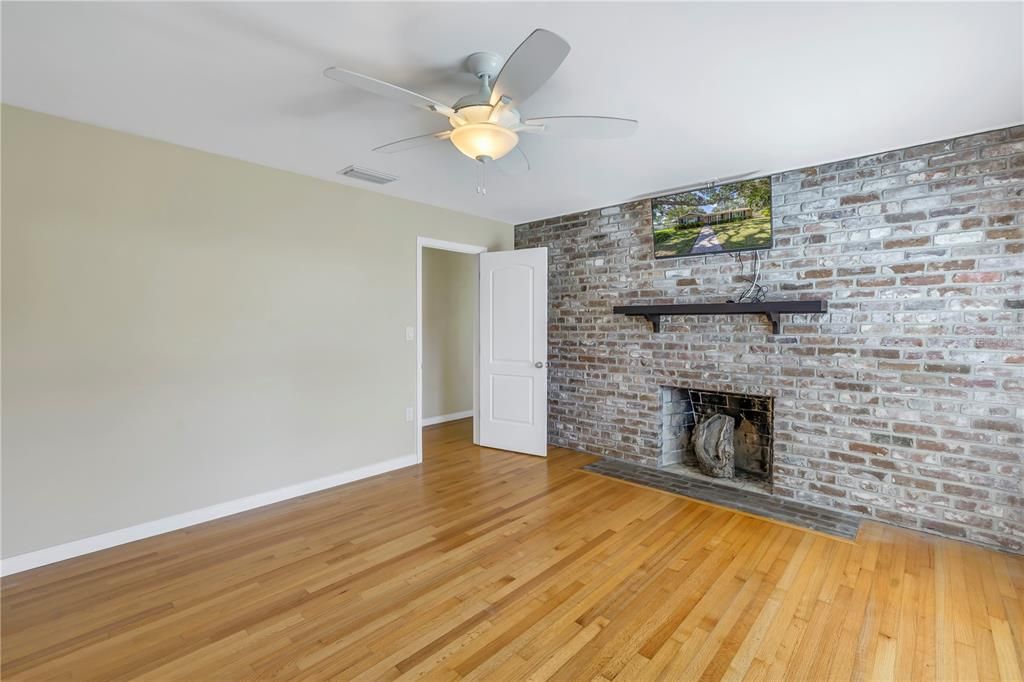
(423, 249, 477, 418)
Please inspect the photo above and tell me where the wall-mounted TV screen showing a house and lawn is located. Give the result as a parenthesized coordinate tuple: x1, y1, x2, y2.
(651, 177, 771, 258)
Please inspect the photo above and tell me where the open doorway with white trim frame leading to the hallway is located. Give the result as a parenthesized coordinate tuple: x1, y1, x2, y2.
(416, 237, 486, 462)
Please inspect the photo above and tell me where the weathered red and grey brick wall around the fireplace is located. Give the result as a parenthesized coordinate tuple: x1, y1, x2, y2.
(516, 126, 1024, 552)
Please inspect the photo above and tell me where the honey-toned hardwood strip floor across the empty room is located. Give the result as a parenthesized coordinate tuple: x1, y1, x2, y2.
(2, 421, 1024, 680)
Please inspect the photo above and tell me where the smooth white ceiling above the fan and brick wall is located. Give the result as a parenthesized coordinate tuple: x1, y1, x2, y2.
(2, 2, 1024, 222)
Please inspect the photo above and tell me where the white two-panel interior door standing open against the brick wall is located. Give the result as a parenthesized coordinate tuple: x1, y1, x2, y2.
(479, 247, 548, 457)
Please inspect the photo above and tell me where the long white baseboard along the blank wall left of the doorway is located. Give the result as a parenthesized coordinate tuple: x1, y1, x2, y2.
(0, 455, 417, 576)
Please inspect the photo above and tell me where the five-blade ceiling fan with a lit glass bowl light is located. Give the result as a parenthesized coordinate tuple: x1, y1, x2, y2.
(324, 29, 637, 172)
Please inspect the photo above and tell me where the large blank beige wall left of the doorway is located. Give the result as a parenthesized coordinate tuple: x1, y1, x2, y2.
(0, 106, 512, 557)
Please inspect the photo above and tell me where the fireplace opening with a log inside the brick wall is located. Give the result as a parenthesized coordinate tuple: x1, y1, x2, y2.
(660, 386, 774, 491)
